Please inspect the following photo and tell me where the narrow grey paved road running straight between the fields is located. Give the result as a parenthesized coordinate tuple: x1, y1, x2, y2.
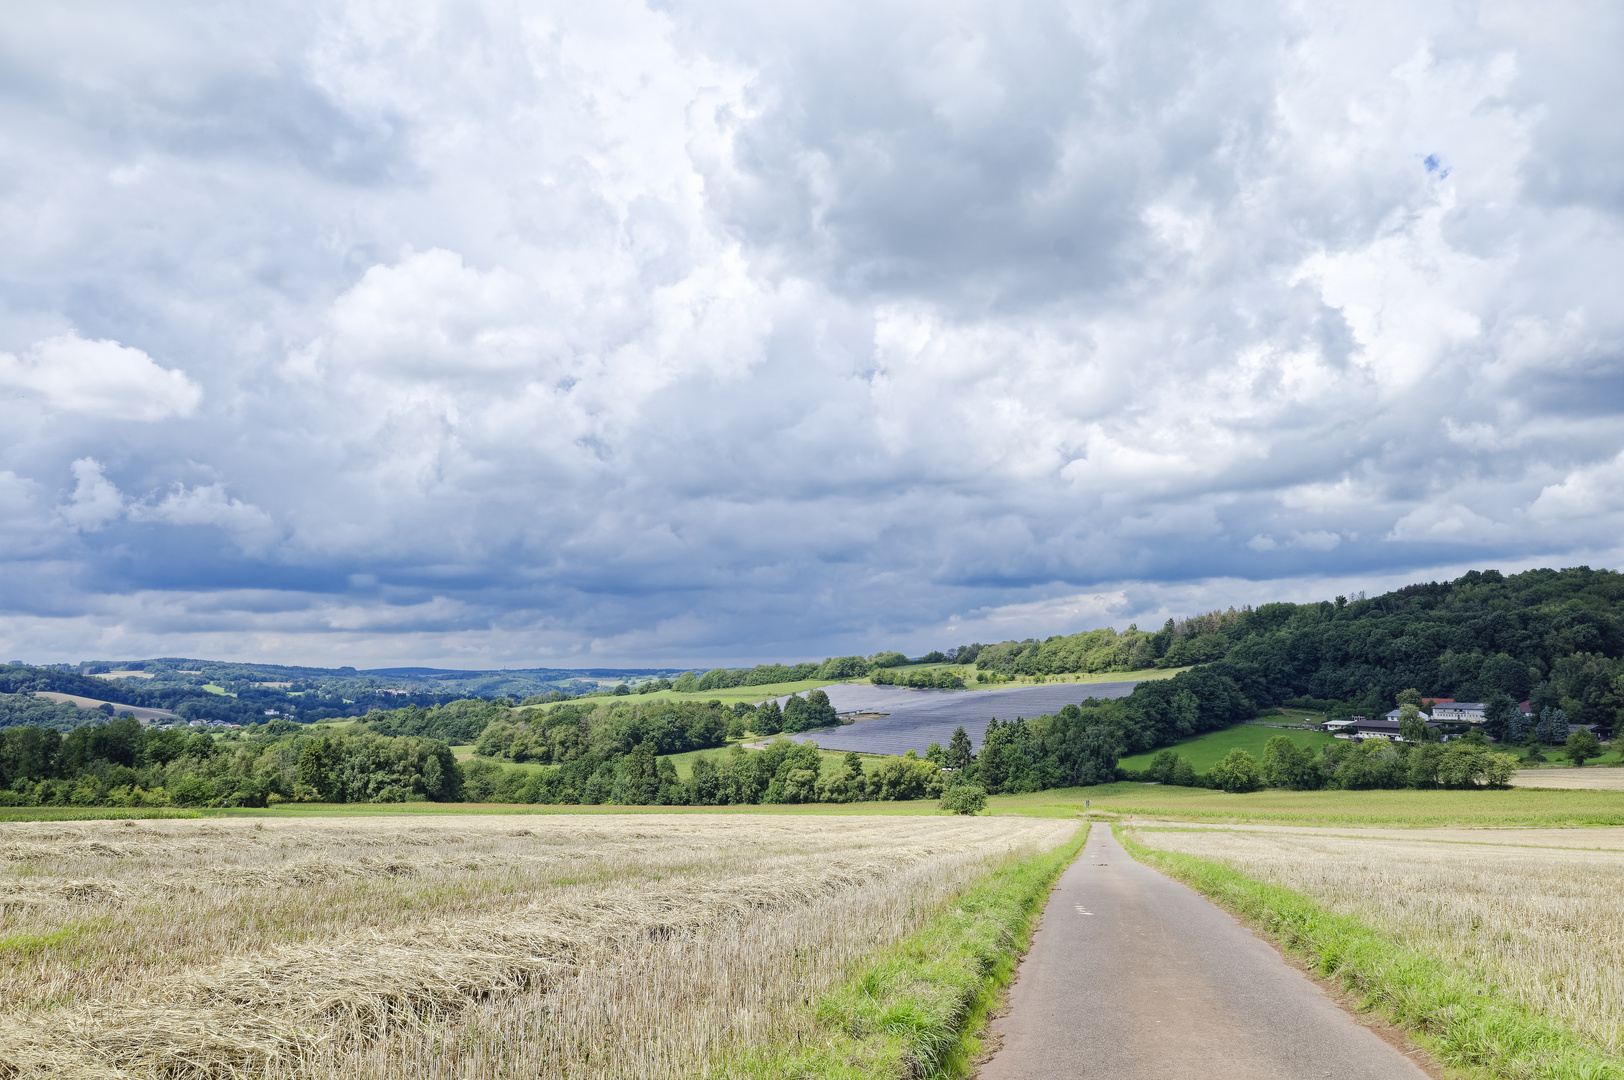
(979, 825, 1426, 1080)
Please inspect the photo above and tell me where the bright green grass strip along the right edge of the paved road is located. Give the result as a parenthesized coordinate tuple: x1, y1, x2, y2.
(1116, 828, 1624, 1080)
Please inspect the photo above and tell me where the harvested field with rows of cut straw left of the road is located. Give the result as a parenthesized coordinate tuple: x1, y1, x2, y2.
(0, 815, 1077, 1080)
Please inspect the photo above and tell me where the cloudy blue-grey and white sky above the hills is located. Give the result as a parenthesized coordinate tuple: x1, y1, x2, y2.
(0, 0, 1624, 666)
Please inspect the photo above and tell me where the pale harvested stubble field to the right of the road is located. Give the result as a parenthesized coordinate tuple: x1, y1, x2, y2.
(1134, 828, 1624, 1054)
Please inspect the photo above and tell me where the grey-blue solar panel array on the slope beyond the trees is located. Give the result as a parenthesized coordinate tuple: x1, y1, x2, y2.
(780, 682, 1138, 754)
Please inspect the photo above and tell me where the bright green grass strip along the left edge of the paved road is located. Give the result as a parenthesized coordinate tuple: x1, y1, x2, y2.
(711, 823, 1088, 1080)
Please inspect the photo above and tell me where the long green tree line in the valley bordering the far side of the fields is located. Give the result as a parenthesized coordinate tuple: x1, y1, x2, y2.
(0, 666, 1546, 810)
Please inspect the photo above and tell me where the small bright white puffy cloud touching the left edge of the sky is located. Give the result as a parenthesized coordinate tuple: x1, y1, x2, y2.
(0, 333, 203, 422)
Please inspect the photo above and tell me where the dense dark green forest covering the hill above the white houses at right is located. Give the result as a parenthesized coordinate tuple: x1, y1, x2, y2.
(953, 567, 1624, 728)
